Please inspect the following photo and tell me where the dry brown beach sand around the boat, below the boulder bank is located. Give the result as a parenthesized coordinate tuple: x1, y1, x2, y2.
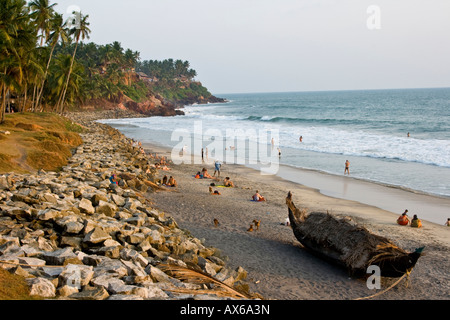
(145, 144, 450, 300)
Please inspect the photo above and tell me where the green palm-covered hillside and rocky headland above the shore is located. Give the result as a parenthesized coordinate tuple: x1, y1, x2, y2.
(0, 0, 224, 122)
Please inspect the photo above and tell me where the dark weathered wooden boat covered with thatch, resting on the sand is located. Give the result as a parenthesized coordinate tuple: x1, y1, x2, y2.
(286, 192, 423, 278)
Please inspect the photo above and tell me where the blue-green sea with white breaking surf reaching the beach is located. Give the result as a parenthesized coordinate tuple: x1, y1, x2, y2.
(101, 88, 450, 221)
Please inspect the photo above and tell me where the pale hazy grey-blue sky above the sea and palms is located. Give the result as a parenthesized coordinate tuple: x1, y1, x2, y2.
(53, 0, 450, 94)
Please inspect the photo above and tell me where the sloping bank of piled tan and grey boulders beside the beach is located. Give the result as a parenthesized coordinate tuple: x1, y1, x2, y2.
(0, 122, 257, 300)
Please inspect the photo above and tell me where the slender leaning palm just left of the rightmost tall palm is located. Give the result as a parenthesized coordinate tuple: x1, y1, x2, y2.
(35, 13, 69, 110)
